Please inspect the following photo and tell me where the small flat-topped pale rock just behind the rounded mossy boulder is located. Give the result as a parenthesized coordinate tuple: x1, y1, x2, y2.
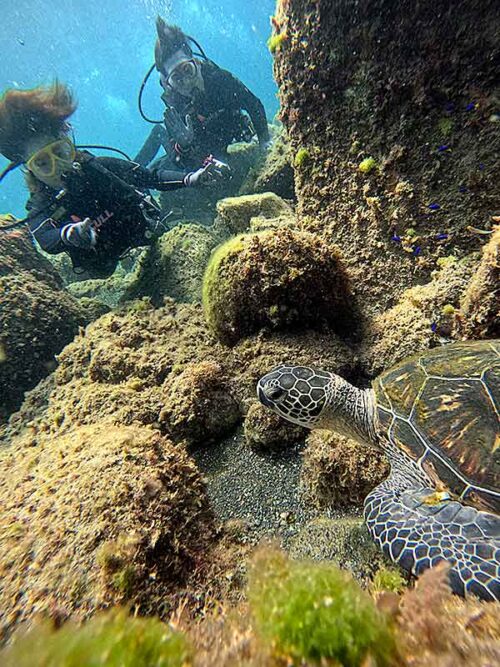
(214, 192, 294, 238)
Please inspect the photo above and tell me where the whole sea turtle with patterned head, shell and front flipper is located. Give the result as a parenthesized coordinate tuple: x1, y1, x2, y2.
(257, 340, 500, 600)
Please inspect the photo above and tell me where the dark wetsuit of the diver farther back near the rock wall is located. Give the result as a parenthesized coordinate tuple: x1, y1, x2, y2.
(135, 61, 269, 169)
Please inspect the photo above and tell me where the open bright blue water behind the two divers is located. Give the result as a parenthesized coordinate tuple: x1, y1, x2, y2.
(0, 0, 278, 216)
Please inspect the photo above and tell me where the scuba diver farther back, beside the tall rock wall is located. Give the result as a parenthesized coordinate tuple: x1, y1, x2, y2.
(135, 17, 270, 169)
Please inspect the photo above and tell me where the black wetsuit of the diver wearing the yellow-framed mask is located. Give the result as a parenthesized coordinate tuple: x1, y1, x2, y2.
(26, 152, 185, 278)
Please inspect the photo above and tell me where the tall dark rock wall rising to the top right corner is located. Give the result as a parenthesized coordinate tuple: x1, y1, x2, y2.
(274, 0, 500, 316)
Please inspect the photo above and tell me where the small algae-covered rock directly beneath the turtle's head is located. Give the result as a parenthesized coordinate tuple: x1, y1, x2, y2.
(244, 403, 308, 451)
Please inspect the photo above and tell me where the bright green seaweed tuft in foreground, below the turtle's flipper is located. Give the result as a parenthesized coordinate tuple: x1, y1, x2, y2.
(249, 550, 396, 667)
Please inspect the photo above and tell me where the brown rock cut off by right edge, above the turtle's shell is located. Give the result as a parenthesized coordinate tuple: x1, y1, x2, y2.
(457, 227, 500, 338)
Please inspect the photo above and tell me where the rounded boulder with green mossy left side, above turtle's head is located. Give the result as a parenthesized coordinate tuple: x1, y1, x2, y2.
(203, 228, 353, 344)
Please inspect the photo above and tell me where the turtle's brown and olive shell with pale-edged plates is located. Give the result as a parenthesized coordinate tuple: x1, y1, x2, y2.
(373, 340, 500, 513)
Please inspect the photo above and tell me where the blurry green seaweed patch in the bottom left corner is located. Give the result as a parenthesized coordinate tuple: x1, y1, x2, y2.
(0, 609, 193, 667)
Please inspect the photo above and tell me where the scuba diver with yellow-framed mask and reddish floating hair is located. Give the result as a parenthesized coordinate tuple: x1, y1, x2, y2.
(0, 82, 228, 278)
